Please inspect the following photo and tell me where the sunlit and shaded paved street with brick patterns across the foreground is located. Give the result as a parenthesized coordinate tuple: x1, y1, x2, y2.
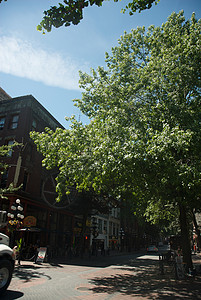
(1, 253, 201, 300)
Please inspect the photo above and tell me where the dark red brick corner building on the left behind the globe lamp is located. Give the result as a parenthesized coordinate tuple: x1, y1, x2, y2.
(0, 88, 74, 255)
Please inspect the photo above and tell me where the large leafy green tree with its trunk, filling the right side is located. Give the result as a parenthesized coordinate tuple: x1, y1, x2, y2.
(31, 12, 201, 267)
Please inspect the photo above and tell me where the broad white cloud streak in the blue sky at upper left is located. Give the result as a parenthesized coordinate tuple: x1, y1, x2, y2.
(0, 36, 82, 90)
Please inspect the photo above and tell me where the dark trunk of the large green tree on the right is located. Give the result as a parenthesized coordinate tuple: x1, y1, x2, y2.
(179, 204, 193, 270)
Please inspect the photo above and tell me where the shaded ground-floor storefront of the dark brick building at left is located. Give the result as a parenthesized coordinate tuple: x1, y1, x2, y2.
(1, 195, 74, 256)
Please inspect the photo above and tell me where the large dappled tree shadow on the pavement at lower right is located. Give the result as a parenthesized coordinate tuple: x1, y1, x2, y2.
(89, 260, 201, 300)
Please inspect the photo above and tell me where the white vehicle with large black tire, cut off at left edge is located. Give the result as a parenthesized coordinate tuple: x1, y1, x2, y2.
(0, 233, 15, 295)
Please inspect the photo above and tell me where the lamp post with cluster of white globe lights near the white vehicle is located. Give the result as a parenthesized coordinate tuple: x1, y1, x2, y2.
(7, 199, 24, 247)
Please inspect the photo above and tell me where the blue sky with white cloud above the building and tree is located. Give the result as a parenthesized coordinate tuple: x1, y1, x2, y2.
(0, 0, 201, 127)
